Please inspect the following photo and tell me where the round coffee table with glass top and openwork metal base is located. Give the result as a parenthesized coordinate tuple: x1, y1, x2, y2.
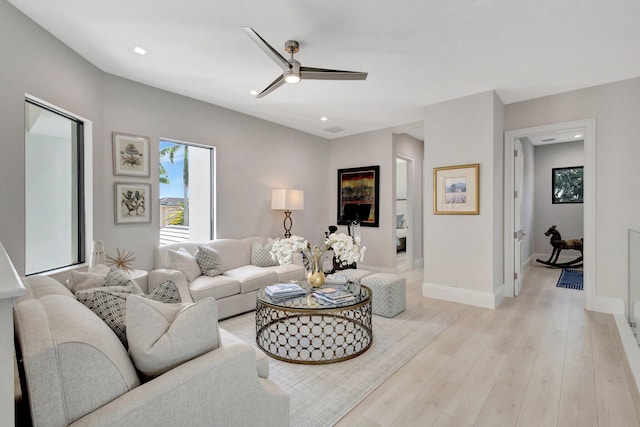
(256, 282, 373, 364)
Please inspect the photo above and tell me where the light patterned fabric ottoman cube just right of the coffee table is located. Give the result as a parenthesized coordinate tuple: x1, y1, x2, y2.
(360, 273, 407, 317)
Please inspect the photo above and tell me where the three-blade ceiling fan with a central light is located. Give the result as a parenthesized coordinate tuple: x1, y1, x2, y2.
(242, 27, 367, 98)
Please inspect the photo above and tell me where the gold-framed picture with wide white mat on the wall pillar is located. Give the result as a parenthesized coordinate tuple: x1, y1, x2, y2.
(433, 163, 480, 215)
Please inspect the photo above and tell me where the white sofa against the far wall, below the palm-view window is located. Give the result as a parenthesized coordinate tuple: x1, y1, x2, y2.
(148, 237, 305, 319)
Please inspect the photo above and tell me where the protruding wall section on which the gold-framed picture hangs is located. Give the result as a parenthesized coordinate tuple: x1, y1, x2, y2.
(423, 91, 503, 306)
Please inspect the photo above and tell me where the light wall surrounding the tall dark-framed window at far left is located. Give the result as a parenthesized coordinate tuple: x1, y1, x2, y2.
(0, 0, 104, 274)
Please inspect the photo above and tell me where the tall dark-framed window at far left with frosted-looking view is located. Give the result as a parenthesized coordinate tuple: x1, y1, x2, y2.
(25, 98, 91, 274)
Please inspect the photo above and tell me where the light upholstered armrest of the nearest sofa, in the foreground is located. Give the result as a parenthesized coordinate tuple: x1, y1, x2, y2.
(72, 342, 289, 427)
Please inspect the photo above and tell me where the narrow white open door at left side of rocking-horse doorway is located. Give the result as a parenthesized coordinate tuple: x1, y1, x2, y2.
(513, 139, 525, 296)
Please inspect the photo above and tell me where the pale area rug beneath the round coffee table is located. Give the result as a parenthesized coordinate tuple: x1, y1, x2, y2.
(220, 312, 457, 427)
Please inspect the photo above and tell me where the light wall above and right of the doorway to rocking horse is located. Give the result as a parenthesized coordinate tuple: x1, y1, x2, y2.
(505, 78, 640, 301)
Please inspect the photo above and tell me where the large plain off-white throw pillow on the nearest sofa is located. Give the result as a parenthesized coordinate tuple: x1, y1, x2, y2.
(127, 295, 220, 377)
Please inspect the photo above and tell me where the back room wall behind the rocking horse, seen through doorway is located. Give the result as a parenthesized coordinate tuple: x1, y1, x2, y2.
(532, 141, 584, 259)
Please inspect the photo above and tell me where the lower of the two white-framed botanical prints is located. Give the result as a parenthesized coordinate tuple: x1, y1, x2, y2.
(113, 182, 151, 224)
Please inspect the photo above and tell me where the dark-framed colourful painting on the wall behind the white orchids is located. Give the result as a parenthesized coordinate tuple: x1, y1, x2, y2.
(338, 166, 380, 227)
